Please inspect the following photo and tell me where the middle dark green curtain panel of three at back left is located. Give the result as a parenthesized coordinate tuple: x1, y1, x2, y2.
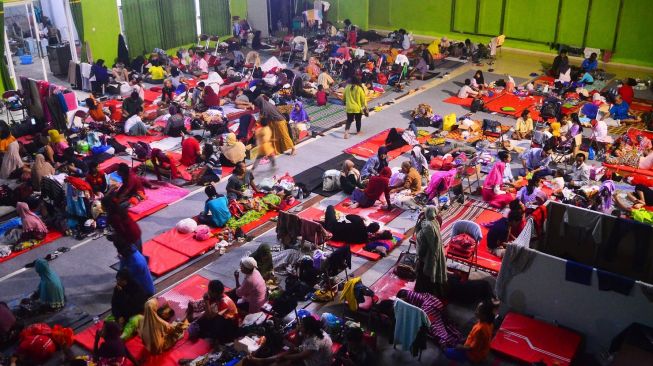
(159, 0, 196, 49)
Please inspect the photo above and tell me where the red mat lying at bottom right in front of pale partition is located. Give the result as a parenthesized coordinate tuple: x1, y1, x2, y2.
(490, 313, 581, 365)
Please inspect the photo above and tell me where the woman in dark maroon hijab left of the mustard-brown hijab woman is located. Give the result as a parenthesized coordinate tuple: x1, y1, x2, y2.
(93, 321, 139, 365)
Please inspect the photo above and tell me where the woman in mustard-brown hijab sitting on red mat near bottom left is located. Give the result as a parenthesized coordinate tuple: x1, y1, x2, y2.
(139, 298, 184, 354)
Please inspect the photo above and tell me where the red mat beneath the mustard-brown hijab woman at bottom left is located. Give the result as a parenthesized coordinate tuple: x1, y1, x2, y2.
(75, 322, 211, 366)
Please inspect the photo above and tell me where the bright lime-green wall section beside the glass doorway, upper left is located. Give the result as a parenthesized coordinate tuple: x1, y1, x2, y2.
(82, 0, 120, 64)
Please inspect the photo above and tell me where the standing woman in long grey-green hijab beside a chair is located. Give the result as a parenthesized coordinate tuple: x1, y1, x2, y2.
(415, 206, 447, 297)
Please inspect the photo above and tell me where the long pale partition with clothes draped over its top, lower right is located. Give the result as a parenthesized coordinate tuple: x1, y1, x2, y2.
(502, 252, 653, 353)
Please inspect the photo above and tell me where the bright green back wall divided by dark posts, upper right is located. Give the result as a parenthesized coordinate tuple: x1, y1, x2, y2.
(366, 0, 653, 67)
